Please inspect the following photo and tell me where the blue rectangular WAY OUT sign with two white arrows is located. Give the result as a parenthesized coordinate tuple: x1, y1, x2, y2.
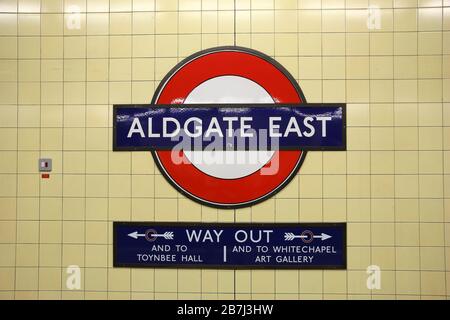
(113, 222, 346, 269)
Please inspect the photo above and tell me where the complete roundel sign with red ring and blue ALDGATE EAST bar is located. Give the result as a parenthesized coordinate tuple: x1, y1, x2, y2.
(113, 47, 345, 208)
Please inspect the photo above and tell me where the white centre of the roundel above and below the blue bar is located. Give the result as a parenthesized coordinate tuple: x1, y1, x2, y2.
(184, 76, 274, 179)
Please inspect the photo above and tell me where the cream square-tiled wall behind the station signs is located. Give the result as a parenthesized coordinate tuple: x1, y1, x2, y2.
(0, 0, 450, 299)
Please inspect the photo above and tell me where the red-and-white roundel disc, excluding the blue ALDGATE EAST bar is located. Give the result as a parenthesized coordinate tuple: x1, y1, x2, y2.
(153, 48, 306, 207)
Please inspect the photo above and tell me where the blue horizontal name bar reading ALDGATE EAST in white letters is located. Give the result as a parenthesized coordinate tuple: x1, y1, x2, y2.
(113, 104, 346, 151)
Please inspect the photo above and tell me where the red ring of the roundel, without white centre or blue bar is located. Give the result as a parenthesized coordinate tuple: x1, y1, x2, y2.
(152, 47, 306, 208)
